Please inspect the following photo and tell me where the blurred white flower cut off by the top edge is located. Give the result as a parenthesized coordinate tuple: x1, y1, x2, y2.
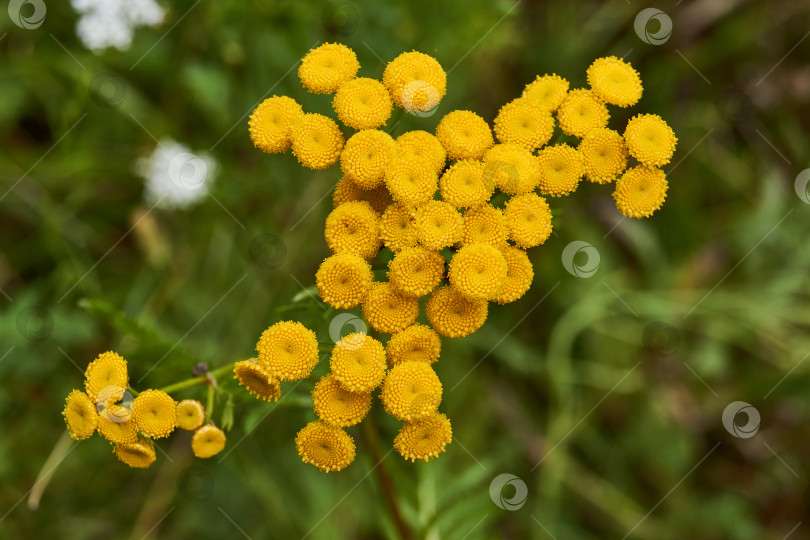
(70, 0, 166, 52)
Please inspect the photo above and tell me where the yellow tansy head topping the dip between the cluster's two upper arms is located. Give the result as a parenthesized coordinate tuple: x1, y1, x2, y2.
(436, 111, 495, 160)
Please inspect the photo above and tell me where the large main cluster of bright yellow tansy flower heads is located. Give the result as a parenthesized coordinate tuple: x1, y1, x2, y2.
(243, 43, 677, 471)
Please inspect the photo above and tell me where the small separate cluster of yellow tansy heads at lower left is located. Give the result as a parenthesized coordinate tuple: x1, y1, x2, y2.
(62, 351, 225, 468)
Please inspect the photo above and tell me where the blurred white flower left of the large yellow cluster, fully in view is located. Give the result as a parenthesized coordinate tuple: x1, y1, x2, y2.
(135, 139, 218, 208)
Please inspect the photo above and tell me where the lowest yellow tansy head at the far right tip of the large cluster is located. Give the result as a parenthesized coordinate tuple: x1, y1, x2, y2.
(613, 165, 668, 218)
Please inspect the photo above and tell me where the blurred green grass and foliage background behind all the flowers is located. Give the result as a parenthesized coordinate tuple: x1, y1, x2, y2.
(0, 0, 810, 539)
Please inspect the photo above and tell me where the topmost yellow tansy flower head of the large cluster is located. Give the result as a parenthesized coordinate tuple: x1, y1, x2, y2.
(298, 43, 360, 94)
